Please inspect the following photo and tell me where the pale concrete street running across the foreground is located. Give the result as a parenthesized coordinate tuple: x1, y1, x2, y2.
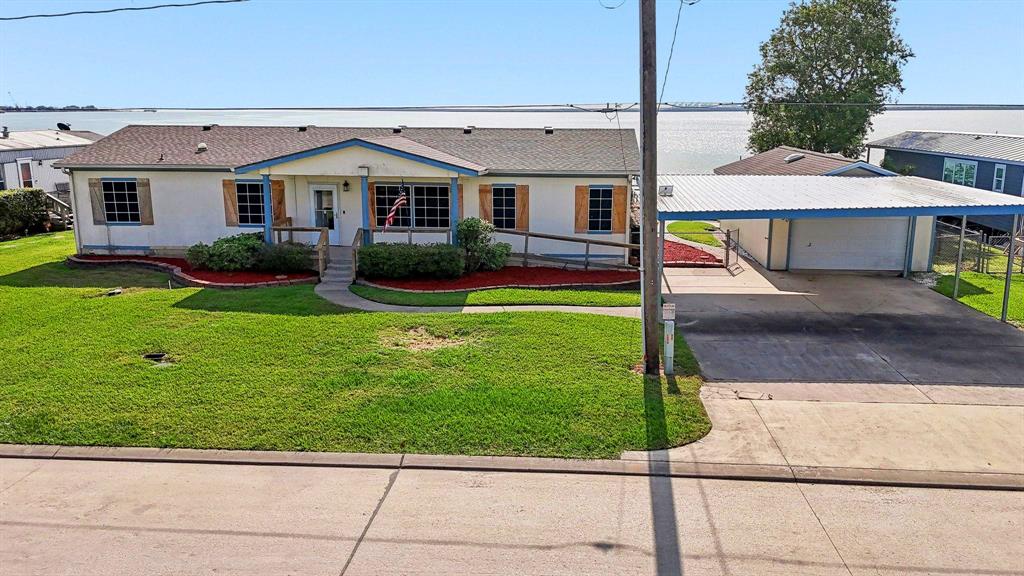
(0, 459, 1024, 575)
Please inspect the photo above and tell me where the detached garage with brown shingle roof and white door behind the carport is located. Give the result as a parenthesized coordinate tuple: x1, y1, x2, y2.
(715, 147, 935, 273)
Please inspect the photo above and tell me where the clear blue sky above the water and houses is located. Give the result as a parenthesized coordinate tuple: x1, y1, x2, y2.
(0, 0, 1024, 107)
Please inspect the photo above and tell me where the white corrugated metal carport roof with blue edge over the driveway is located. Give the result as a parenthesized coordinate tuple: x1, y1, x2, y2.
(657, 174, 1024, 220)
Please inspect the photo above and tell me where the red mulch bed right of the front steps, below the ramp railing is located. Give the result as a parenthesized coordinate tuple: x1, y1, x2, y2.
(373, 266, 640, 292)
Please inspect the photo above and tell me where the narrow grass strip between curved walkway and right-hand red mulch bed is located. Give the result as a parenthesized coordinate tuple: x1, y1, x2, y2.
(349, 284, 640, 306)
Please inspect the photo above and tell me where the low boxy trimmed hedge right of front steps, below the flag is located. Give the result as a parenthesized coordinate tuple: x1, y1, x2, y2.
(358, 244, 466, 278)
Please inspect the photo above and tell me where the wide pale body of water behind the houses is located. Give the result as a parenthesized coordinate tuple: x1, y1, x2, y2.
(0, 110, 1024, 172)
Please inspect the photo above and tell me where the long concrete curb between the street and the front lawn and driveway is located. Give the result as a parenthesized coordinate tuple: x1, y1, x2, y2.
(0, 444, 1024, 491)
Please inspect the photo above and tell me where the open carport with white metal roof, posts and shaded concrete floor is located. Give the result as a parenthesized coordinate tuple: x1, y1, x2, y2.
(658, 174, 1024, 385)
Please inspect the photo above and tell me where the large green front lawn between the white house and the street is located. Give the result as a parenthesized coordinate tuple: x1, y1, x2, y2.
(0, 233, 711, 457)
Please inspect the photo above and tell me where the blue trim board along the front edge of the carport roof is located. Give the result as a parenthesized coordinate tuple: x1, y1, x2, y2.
(657, 205, 1024, 220)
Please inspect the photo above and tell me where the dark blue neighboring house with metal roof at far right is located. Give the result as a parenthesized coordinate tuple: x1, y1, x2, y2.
(867, 130, 1024, 234)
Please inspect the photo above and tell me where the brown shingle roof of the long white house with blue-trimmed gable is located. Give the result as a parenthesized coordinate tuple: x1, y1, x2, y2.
(60, 125, 640, 173)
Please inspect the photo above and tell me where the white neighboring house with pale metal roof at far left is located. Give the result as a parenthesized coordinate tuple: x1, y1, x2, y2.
(0, 126, 102, 202)
